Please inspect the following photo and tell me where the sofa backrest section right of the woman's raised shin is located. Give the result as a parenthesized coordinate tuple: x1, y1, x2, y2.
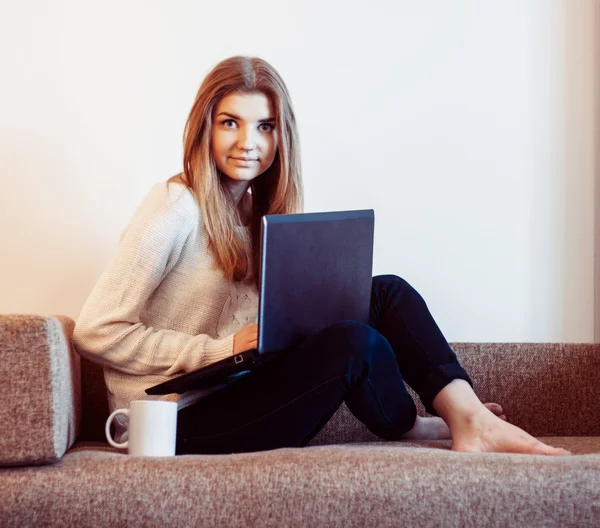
(452, 343, 600, 436)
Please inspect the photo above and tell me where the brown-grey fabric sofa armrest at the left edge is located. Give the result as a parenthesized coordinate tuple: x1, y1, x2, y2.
(0, 315, 81, 466)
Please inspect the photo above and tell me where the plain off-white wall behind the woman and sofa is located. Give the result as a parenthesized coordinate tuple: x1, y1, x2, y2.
(0, 0, 600, 342)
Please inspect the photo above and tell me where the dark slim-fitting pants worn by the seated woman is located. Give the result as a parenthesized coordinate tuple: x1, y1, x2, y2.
(177, 275, 472, 454)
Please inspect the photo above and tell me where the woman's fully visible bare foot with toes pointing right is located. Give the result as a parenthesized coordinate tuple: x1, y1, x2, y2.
(452, 405, 572, 455)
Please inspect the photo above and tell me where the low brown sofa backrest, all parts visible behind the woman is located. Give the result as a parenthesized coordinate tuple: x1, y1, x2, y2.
(82, 343, 600, 445)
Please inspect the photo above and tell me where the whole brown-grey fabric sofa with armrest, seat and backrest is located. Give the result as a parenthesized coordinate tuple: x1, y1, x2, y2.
(0, 315, 600, 527)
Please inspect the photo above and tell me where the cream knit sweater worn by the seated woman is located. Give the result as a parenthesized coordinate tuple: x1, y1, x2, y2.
(73, 182, 258, 441)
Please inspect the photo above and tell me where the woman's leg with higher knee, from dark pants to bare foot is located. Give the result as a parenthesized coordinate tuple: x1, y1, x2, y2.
(370, 275, 569, 455)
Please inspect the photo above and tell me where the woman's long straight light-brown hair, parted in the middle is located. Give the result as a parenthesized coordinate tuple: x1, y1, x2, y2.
(167, 56, 304, 285)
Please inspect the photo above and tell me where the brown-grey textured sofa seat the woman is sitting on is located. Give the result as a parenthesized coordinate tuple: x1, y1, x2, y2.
(0, 439, 600, 528)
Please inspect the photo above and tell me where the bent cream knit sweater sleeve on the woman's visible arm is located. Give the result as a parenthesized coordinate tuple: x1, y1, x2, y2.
(73, 184, 233, 376)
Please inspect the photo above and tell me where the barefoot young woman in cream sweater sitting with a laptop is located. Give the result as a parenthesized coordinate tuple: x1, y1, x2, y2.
(74, 57, 568, 455)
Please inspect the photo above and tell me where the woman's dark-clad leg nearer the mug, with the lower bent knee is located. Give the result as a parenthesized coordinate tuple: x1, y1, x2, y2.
(177, 321, 416, 454)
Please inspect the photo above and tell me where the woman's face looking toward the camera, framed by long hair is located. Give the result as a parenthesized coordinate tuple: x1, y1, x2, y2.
(211, 92, 277, 186)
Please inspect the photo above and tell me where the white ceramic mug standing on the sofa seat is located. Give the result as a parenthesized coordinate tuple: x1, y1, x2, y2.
(104, 400, 177, 456)
